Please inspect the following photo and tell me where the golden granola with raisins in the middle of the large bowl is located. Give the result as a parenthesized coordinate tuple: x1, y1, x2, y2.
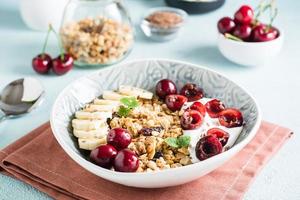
(110, 97, 191, 171)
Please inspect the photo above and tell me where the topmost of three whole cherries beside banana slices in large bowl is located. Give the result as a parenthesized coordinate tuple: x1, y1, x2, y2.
(107, 128, 131, 150)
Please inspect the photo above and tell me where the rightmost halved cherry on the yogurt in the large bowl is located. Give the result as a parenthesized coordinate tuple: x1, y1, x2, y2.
(219, 108, 243, 128)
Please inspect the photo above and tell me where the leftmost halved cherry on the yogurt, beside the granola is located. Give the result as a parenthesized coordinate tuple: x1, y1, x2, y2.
(180, 110, 204, 130)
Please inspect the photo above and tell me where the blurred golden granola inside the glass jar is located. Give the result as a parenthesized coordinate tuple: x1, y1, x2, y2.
(60, 17, 133, 64)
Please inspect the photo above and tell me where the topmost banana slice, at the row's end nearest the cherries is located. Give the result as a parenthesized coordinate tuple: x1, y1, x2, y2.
(119, 85, 153, 99)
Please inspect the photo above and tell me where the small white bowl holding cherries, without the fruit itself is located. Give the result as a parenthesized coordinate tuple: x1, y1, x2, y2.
(218, 32, 284, 66)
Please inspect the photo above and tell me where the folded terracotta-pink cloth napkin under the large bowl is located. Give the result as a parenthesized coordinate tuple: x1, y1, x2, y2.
(0, 122, 292, 200)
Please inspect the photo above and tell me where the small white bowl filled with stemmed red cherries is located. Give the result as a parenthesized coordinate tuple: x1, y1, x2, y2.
(217, 2, 284, 66)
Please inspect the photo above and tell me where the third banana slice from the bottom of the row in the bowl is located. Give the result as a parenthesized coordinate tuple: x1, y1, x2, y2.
(72, 119, 107, 131)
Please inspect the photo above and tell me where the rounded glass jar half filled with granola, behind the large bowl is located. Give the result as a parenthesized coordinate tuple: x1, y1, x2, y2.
(60, 0, 134, 67)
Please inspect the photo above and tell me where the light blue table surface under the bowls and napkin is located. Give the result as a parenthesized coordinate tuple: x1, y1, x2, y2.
(0, 0, 300, 200)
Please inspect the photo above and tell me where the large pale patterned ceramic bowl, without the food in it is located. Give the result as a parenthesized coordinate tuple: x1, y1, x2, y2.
(50, 59, 261, 188)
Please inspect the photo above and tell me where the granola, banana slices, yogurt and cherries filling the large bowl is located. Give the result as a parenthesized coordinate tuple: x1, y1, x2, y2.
(72, 79, 243, 172)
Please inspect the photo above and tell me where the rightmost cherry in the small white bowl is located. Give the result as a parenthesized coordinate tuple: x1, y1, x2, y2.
(252, 25, 279, 42)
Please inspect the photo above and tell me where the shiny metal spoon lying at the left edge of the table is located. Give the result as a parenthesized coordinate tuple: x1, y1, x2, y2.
(0, 78, 45, 121)
